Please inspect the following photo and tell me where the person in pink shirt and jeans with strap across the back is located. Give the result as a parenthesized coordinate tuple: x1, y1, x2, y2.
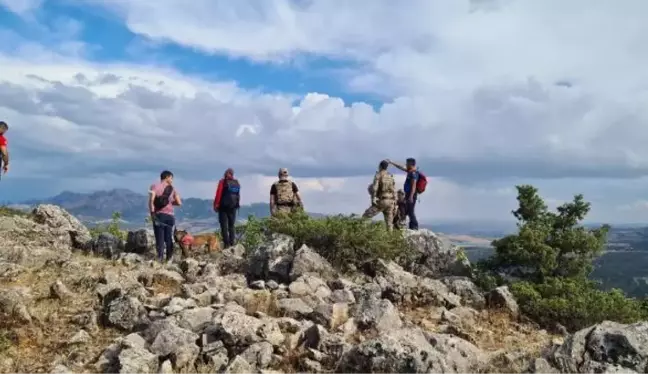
(148, 170, 182, 262)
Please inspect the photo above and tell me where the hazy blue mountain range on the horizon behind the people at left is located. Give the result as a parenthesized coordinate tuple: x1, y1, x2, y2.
(13, 189, 324, 229)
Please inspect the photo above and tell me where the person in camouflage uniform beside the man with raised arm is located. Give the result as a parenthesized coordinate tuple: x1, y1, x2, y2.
(362, 161, 396, 231)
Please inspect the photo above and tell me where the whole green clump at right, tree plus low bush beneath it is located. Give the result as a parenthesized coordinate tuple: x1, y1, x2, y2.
(476, 185, 648, 331)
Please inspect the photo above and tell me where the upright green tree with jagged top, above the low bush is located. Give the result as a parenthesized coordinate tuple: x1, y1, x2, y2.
(491, 185, 609, 282)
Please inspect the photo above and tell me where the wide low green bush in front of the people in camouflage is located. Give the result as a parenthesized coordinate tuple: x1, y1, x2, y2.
(238, 212, 413, 270)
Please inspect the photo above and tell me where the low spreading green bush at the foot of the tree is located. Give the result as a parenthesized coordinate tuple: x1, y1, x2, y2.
(511, 278, 648, 331)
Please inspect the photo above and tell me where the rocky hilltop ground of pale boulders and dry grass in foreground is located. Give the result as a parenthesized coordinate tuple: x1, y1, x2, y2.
(0, 205, 648, 374)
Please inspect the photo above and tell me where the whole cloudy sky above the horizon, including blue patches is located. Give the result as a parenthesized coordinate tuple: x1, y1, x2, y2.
(0, 0, 648, 223)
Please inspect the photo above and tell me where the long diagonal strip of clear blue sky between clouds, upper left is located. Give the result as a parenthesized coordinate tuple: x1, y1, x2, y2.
(0, 1, 382, 108)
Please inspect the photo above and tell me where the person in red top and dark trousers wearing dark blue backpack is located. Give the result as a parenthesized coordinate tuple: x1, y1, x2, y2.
(214, 168, 241, 248)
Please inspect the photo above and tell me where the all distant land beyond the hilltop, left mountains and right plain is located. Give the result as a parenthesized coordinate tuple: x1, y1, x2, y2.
(12, 189, 648, 296)
